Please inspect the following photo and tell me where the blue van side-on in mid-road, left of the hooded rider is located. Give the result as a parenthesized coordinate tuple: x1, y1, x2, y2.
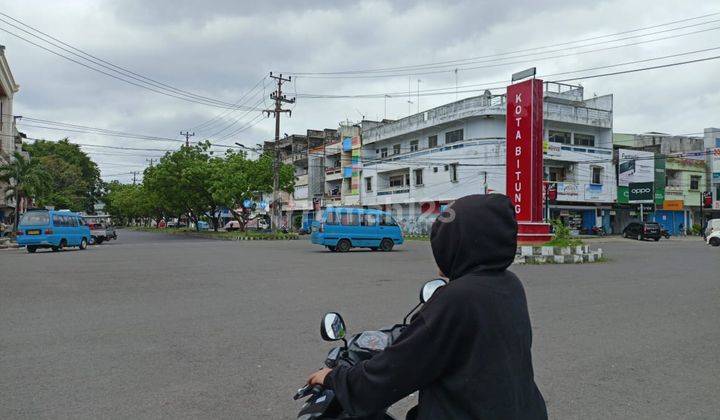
(310, 207, 403, 252)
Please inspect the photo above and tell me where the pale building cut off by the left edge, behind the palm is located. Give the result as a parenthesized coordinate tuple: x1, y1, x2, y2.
(0, 45, 22, 221)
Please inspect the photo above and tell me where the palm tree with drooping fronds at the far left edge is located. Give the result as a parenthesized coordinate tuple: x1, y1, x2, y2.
(0, 152, 51, 231)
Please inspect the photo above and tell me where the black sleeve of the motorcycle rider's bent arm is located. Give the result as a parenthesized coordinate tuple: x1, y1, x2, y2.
(325, 302, 458, 416)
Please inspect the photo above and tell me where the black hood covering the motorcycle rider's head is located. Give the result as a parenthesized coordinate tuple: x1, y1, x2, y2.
(430, 194, 517, 280)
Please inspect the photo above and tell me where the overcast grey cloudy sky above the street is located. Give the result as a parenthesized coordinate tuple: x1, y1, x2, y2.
(0, 0, 720, 181)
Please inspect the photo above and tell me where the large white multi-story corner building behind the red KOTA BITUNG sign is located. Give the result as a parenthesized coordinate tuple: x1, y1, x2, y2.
(360, 83, 616, 233)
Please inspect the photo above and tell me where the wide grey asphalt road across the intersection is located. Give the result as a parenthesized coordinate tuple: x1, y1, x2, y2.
(0, 231, 720, 419)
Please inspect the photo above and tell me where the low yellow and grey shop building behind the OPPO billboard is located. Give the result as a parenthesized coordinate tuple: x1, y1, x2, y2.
(614, 132, 707, 235)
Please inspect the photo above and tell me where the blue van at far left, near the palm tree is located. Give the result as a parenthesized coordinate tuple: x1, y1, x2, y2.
(17, 210, 90, 253)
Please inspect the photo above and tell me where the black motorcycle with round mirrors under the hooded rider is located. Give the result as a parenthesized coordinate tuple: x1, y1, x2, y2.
(293, 278, 447, 420)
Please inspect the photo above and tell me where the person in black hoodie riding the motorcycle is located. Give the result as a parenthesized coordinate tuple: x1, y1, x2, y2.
(308, 194, 547, 420)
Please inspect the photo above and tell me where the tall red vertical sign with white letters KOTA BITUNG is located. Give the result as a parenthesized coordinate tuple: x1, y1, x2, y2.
(505, 79, 543, 222)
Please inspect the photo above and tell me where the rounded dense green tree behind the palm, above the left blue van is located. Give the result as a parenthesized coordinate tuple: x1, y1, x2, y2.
(24, 139, 102, 213)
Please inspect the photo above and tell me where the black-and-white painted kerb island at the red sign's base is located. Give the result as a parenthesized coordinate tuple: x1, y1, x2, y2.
(514, 245, 604, 264)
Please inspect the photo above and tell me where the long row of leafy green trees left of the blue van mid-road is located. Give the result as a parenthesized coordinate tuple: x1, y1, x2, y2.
(105, 143, 295, 229)
